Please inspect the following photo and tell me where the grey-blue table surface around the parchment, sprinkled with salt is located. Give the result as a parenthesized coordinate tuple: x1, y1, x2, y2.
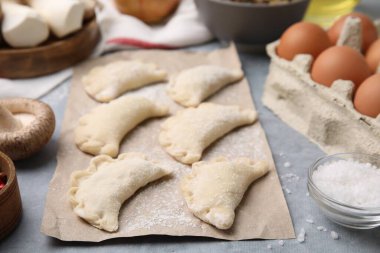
(0, 0, 380, 253)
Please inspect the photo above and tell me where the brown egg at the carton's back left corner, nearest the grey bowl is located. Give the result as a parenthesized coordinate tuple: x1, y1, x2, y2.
(277, 22, 332, 61)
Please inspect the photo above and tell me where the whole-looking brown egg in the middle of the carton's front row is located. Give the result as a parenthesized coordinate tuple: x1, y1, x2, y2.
(311, 46, 371, 87)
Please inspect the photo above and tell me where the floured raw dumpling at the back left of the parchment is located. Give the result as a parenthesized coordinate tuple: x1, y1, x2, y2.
(82, 61, 166, 102)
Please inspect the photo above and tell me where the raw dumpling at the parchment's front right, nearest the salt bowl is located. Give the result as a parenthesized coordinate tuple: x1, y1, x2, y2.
(181, 158, 269, 229)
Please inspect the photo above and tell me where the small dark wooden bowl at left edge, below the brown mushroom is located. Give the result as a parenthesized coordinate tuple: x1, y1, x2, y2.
(0, 152, 22, 240)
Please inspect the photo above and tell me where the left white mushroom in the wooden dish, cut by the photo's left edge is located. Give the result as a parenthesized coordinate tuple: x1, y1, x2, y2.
(1, 0, 49, 47)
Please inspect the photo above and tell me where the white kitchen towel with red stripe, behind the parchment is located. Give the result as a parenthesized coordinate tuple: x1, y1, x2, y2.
(0, 0, 212, 98)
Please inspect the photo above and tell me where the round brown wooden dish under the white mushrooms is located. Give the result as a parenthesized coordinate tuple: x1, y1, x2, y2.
(0, 19, 100, 78)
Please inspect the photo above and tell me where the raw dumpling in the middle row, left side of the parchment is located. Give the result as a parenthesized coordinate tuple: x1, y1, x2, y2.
(75, 96, 168, 157)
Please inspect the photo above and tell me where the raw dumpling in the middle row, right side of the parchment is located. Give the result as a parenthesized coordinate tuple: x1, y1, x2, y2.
(159, 103, 257, 164)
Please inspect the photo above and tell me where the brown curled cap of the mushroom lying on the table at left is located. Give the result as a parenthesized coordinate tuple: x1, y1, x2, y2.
(0, 98, 55, 160)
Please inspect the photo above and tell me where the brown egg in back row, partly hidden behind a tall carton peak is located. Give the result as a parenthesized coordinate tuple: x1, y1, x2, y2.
(327, 12, 377, 52)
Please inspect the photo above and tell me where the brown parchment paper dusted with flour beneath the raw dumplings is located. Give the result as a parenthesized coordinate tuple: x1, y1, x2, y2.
(41, 46, 294, 242)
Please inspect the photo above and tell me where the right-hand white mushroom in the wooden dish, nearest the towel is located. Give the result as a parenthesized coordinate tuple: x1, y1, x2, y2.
(26, 0, 85, 38)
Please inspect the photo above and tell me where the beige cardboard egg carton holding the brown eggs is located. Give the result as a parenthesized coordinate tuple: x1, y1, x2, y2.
(262, 19, 380, 154)
